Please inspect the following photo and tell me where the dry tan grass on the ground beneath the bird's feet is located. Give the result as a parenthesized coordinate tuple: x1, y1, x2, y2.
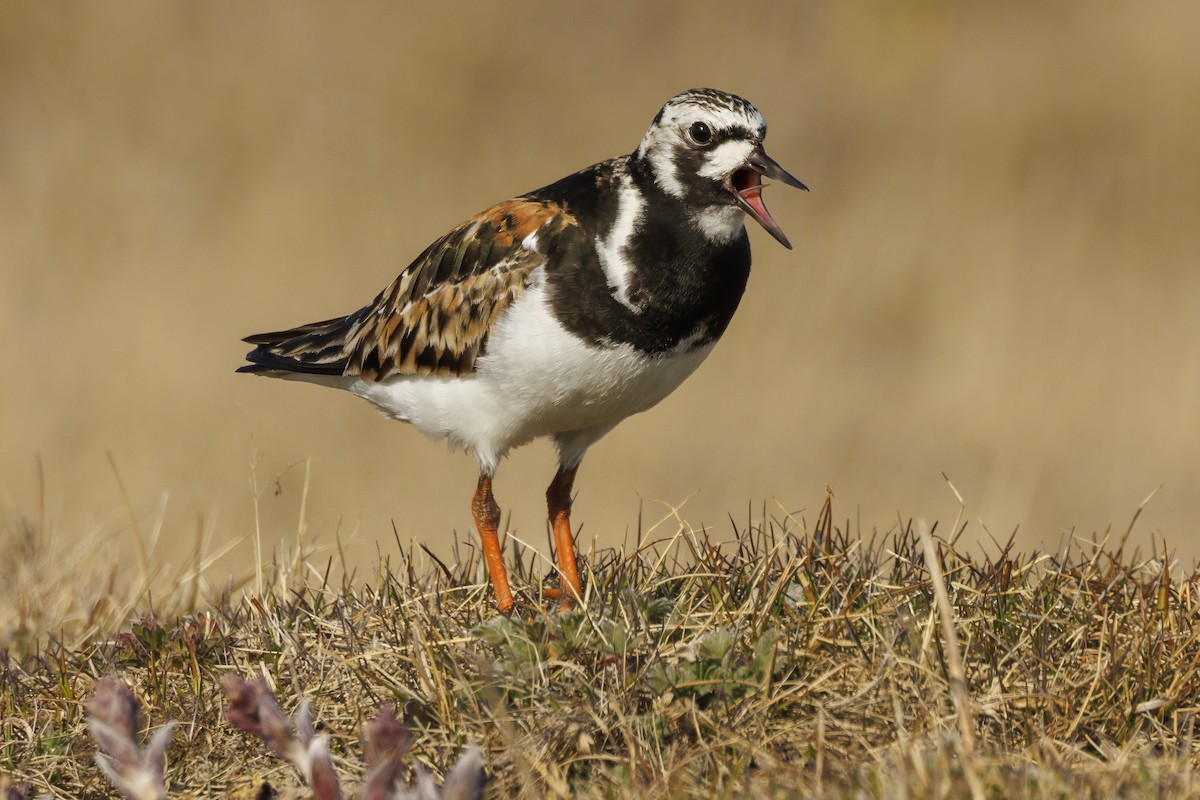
(0, 491, 1200, 798)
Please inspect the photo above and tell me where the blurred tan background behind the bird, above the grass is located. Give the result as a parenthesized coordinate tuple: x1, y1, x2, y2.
(0, 1, 1200, 575)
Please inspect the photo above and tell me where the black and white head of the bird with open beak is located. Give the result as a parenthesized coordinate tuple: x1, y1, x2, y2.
(634, 89, 808, 248)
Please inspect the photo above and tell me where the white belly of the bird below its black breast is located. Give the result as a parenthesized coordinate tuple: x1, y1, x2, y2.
(347, 285, 712, 469)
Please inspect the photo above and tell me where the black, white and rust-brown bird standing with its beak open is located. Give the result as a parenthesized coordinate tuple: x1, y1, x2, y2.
(238, 89, 808, 615)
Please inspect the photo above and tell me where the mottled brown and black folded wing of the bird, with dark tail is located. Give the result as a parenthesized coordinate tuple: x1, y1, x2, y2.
(241, 199, 577, 380)
